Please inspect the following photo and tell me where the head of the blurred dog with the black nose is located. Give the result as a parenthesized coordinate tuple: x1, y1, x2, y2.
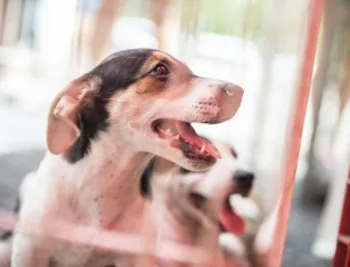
(141, 140, 255, 234)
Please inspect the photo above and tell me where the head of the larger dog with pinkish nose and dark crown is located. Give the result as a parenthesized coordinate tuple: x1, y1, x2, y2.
(47, 49, 243, 170)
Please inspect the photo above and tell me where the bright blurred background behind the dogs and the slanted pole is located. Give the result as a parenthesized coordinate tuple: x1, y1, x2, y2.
(0, 0, 350, 267)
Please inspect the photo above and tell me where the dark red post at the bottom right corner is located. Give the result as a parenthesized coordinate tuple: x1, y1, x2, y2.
(333, 168, 350, 267)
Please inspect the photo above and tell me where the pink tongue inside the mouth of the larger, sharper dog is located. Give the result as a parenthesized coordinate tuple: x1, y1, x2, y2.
(176, 121, 221, 159)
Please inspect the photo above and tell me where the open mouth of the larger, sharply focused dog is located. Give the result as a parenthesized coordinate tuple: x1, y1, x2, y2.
(152, 119, 221, 162)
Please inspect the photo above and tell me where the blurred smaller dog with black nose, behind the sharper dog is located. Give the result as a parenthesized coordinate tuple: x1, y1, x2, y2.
(140, 137, 255, 267)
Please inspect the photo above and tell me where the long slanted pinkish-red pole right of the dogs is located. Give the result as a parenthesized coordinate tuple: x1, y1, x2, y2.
(267, 0, 323, 267)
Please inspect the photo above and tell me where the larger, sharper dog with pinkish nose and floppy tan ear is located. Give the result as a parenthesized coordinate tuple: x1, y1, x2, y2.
(11, 49, 243, 267)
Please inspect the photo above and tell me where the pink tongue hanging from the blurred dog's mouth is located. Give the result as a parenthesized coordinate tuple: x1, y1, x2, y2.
(219, 205, 244, 235)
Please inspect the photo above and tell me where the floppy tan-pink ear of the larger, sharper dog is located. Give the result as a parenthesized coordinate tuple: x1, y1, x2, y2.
(47, 75, 100, 155)
